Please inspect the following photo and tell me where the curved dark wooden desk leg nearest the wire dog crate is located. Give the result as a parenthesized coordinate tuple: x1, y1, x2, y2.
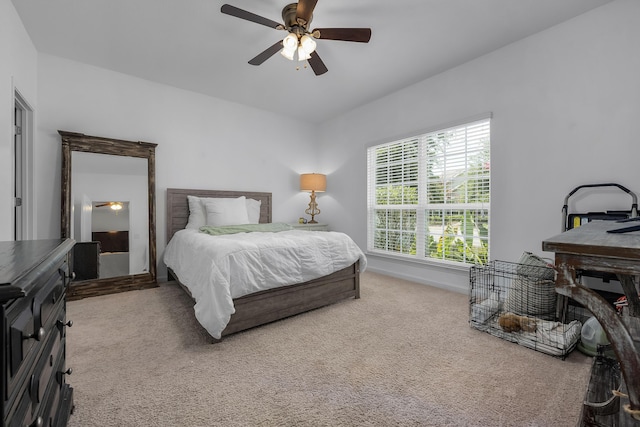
(556, 263, 640, 420)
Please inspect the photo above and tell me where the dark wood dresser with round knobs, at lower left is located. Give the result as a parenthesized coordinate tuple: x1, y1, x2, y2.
(0, 239, 74, 427)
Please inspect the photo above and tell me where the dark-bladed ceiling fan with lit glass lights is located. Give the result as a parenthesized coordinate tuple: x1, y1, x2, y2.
(220, 0, 371, 76)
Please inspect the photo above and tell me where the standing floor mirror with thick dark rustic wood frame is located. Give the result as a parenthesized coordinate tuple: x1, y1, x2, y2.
(58, 131, 157, 300)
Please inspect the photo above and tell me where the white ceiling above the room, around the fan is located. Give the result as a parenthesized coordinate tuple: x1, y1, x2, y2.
(12, 0, 612, 123)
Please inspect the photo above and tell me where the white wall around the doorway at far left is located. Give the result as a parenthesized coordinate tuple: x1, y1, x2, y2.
(0, 0, 37, 240)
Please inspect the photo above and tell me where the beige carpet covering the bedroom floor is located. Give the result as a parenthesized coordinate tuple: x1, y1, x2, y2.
(67, 272, 591, 427)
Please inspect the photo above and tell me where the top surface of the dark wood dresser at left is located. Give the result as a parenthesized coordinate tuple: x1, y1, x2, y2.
(0, 239, 74, 301)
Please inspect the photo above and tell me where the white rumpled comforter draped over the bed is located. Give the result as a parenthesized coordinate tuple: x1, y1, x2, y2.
(164, 230, 367, 338)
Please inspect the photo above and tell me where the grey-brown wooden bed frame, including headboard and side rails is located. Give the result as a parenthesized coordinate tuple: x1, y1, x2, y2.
(167, 188, 360, 336)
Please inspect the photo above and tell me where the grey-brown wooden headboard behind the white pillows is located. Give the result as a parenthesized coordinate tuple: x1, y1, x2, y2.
(167, 188, 271, 242)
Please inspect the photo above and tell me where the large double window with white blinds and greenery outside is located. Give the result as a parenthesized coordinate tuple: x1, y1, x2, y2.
(367, 119, 491, 264)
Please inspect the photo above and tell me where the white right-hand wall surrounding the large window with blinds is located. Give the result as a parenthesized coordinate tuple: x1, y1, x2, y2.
(319, 0, 640, 291)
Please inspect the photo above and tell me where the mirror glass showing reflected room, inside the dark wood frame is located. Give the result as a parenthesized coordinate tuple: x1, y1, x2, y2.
(71, 152, 149, 279)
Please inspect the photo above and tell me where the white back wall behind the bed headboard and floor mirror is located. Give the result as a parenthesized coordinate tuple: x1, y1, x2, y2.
(36, 54, 316, 277)
